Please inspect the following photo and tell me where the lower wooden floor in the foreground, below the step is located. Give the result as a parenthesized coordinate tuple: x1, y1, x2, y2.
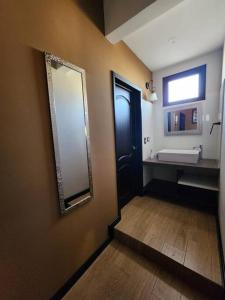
(63, 240, 213, 300)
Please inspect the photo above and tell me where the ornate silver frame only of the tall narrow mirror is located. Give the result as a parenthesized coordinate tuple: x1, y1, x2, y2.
(45, 52, 94, 214)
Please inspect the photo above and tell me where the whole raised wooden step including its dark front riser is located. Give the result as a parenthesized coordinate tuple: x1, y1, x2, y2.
(114, 197, 224, 297)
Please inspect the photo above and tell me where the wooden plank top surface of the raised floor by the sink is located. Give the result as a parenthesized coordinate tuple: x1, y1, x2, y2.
(116, 197, 222, 284)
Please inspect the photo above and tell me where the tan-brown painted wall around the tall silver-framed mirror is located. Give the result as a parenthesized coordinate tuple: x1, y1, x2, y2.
(0, 0, 151, 300)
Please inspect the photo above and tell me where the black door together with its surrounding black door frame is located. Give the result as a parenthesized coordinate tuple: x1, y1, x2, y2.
(114, 73, 142, 207)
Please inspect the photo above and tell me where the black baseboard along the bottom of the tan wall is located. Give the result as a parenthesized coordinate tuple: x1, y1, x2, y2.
(50, 216, 121, 300)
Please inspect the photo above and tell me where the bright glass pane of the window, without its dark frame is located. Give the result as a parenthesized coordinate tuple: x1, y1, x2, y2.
(168, 74, 199, 102)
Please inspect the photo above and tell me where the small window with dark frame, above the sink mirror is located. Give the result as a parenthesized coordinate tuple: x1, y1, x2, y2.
(163, 65, 206, 106)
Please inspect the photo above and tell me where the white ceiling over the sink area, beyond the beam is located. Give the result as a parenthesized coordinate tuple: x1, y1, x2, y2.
(123, 0, 225, 71)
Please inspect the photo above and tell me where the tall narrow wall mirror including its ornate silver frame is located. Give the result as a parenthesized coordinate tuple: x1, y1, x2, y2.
(45, 54, 93, 213)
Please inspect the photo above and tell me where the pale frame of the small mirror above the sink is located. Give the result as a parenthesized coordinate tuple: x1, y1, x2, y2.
(164, 102, 202, 136)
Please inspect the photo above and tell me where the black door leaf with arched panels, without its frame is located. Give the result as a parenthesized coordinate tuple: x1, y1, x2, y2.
(114, 85, 136, 206)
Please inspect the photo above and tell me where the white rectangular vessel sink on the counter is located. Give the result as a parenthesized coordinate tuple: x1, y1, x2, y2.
(157, 149, 200, 164)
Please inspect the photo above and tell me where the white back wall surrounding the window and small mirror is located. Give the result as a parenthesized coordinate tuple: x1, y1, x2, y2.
(153, 49, 222, 159)
